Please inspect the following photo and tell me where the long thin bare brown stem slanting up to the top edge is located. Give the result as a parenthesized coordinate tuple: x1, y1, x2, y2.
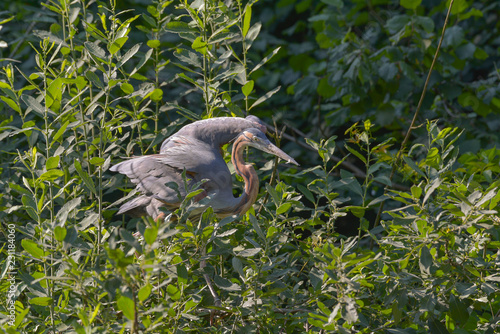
(370, 0, 454, 244)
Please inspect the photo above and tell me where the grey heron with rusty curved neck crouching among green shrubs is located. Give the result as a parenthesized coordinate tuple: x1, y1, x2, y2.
(110, 116, 298, 220)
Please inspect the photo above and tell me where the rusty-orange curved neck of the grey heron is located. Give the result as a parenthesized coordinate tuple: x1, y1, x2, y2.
(231, 139, 259, 214)
